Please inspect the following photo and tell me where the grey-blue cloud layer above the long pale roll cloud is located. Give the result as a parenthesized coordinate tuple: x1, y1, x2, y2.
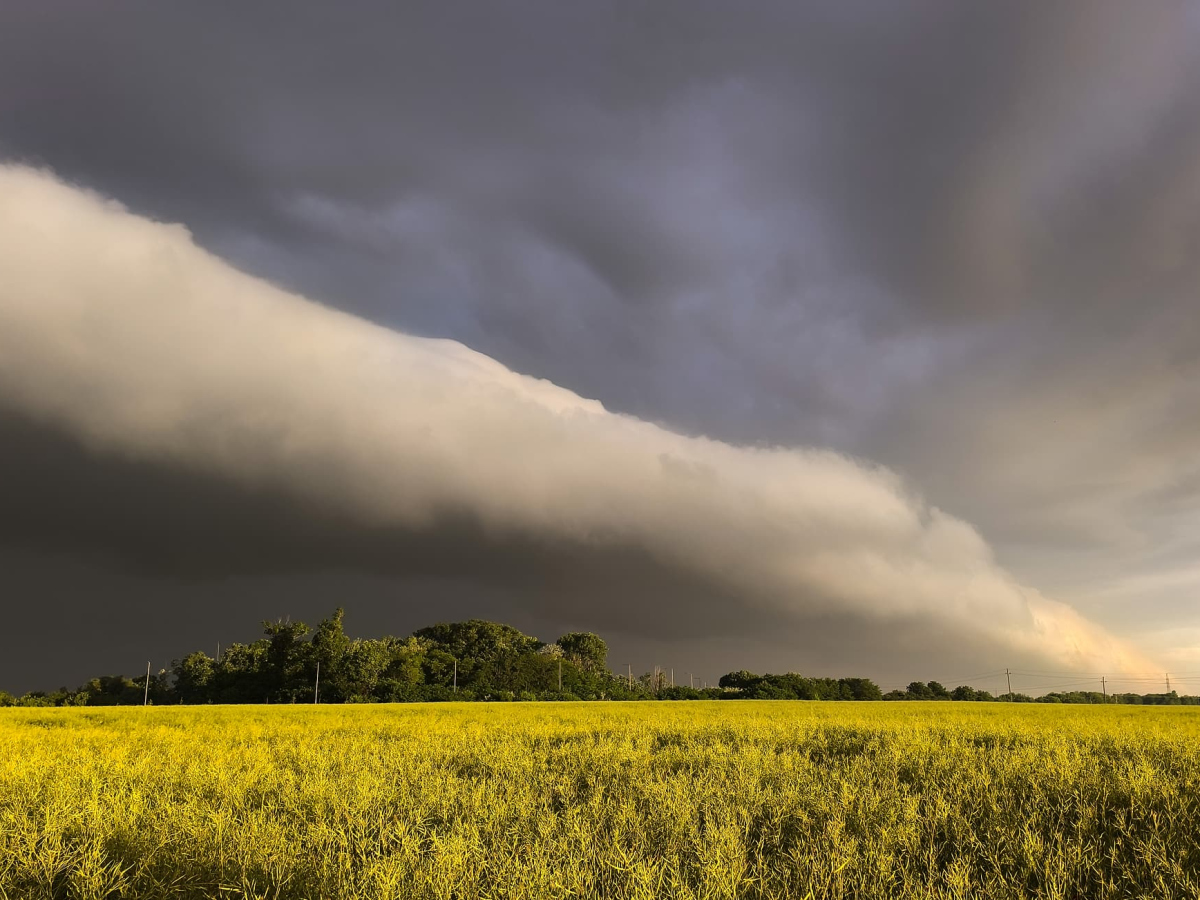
(0, 2, 1200, 686)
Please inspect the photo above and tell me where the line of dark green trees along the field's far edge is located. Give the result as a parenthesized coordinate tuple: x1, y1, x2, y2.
(0, 608, 1200, 707)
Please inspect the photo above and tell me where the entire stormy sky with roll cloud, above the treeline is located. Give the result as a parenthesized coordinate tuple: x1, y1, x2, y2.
(0, 0, 1200, 692)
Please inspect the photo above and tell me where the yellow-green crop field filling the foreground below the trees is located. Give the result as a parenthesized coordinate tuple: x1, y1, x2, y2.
(0, 701, 1200, 900)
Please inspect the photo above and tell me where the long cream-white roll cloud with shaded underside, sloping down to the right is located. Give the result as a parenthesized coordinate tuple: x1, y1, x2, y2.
(0, 166, 1150, 672)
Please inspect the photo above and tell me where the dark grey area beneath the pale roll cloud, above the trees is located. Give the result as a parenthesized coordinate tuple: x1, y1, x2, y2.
(0, 414, 1022, 690)
